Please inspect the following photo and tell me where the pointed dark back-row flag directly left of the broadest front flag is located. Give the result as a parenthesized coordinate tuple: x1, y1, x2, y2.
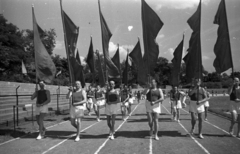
(129, 39, 147, 84)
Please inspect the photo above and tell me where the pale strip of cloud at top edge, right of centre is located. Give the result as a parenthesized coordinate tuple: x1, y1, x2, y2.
(156, 0, 210, 11)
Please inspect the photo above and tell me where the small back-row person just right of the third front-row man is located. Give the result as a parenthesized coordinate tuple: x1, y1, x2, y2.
(121, 85, 129, 120)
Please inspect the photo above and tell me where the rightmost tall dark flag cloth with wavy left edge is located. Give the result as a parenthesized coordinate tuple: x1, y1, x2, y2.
(213, 0, 233, 73)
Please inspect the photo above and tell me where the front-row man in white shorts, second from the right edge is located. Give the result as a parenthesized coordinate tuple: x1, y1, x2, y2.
(189, 78, 209, 139)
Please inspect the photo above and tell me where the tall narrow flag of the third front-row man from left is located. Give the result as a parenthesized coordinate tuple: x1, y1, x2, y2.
(98, 0, 119, 79)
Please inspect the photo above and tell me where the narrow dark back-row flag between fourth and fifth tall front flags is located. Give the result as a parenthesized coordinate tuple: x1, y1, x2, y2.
(172, 35, 184, 86)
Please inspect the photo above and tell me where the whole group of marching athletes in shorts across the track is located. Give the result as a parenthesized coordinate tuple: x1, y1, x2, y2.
(31, 78, 240, 141)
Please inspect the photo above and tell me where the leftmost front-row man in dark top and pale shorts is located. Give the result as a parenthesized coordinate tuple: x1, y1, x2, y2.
(31, 81, 51, 140)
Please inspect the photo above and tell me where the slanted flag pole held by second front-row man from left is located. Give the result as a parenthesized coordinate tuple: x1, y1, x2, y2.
(60, 0, 73, 86)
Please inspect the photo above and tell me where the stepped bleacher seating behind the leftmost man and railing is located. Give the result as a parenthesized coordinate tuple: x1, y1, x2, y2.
(0, 81, 69, 124)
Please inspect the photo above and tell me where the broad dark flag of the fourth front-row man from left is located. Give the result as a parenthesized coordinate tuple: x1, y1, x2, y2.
(142, 0, 163, 74)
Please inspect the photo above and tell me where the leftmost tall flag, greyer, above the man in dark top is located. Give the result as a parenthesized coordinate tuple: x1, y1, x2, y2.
(32, 7, 56, 83)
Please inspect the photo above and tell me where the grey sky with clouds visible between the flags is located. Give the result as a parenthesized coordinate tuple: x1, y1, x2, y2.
(0, 0, 240, 72)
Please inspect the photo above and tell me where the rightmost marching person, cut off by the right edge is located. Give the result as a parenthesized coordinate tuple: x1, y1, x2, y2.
(228, 77, 240, 138)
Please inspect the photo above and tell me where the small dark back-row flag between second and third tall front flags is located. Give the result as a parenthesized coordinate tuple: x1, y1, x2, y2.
(86, 37, 95, 75)
